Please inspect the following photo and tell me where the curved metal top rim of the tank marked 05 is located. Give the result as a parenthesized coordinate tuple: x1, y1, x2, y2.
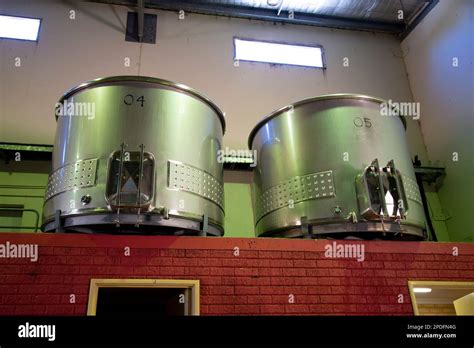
(248, 93, 407, 149)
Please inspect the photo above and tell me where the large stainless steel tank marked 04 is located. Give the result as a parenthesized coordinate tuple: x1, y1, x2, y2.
(43, 76, 225, 235)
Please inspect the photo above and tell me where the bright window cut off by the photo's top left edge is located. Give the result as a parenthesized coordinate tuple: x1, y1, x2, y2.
(0, 15, 41, 41)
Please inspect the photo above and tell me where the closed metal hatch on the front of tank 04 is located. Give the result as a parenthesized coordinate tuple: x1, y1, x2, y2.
(106, 144, 155, 223)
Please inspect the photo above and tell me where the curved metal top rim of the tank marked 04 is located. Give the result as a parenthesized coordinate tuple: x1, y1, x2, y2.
(56, 75, 225, 133)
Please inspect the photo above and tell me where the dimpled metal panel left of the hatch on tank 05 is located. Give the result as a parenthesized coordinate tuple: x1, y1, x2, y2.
(257, 170, 336, 219)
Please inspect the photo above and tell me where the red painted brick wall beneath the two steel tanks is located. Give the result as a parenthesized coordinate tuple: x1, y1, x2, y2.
(0, 233, 474, 315)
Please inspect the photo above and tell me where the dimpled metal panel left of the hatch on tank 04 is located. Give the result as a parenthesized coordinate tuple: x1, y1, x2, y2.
(46, 158, 97, 200)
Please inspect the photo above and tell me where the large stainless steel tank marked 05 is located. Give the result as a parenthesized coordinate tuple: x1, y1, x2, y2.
(249, 94, 425, 239)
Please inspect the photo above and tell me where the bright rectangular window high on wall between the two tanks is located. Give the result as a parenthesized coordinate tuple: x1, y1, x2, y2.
(234, 38, 325, 68)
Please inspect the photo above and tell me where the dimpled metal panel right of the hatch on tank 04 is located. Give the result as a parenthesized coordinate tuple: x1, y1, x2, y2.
(168, 161, 224, 209)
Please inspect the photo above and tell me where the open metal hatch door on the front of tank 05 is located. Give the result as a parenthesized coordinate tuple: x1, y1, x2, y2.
(356, 159, 408, 221)
